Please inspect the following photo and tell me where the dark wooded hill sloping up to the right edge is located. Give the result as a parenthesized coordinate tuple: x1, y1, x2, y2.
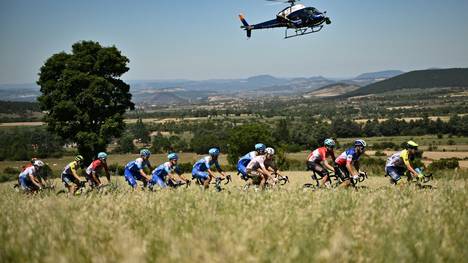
(345, 68, 468, 97)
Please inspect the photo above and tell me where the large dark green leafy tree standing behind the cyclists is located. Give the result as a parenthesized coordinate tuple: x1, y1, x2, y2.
(37, 41, 134, 161)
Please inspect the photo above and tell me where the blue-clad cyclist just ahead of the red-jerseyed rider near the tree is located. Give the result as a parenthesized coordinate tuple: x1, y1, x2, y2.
(124, 149, 153, 189)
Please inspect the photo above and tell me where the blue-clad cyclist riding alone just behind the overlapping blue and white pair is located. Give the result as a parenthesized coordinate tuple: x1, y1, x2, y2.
(192, 148, 227, 189)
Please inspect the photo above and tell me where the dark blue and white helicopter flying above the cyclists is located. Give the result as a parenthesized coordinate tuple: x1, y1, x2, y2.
(239, 0, 331, 39)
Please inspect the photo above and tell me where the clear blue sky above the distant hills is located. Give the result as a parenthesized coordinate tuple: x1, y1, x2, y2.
(0, 0, 468, 84)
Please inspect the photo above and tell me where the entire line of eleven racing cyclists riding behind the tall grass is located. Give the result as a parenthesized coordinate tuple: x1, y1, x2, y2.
(18, 138, 422, 194)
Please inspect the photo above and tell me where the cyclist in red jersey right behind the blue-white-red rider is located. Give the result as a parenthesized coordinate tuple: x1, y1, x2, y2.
(307, 139, 336, 186)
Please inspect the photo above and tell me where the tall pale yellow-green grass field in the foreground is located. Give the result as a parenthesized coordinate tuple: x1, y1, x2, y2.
(0, 171, 468, 262)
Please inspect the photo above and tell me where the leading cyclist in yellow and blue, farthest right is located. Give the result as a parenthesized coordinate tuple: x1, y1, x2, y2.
(385, 141, 424, 184)
